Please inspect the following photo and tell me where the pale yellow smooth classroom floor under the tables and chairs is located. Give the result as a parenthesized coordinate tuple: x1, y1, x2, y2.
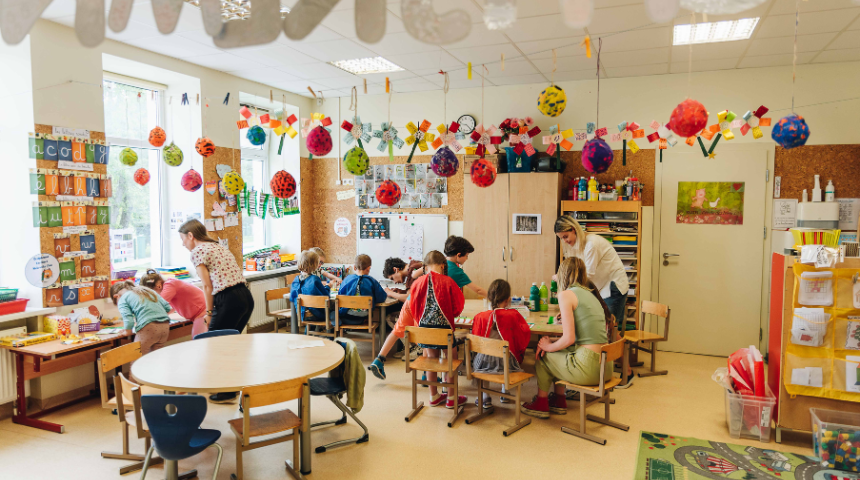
(0, 343, 811, 480)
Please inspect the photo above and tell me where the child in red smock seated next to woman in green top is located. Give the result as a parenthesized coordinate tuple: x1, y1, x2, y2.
(472, 279, 532, 407)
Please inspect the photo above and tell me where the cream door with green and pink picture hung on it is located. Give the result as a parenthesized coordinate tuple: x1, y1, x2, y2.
(657, 144, 767, 356)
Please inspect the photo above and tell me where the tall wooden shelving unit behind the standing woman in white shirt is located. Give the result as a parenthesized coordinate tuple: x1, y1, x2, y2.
(559, 200, 642, 330)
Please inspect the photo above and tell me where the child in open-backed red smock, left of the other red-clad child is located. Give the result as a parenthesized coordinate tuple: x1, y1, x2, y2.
(409, 250, 467, 408)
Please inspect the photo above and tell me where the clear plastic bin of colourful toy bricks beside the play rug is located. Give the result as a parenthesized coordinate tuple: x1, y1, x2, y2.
(809, 408, 860, 472)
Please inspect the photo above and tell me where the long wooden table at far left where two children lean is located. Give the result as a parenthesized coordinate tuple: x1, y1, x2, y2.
(0, 314, 193, 433)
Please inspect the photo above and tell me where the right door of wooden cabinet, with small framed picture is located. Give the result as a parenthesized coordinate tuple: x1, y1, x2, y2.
(508, 173, 561, 296)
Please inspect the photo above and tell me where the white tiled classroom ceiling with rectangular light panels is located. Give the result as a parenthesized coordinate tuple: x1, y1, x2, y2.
(42, 0, 860, 97)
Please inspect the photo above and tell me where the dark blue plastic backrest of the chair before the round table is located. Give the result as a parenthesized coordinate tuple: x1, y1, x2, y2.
(140, 395, 206, 460)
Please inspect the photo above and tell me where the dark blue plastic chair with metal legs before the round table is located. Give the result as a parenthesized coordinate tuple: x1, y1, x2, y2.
(140, 395, 224, 480)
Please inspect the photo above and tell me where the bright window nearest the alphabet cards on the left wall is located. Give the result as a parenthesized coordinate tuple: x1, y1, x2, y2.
(104, 78, 163, 270)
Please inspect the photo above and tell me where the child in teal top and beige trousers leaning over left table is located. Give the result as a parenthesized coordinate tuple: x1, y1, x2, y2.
(110, 280, 170, 355)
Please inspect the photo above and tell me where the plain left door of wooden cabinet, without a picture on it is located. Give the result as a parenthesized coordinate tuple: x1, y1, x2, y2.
(463, 174, 510, 298)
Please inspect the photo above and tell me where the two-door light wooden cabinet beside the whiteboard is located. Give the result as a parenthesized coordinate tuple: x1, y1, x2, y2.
(463, 173, 561, 298)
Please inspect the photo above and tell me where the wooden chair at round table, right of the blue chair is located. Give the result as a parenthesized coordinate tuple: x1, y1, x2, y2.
(227, 378, 310, 480)
